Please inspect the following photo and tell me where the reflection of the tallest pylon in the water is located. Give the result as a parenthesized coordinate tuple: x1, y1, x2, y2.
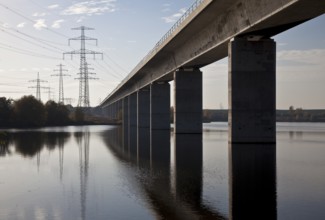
(77, 131, 90, 220)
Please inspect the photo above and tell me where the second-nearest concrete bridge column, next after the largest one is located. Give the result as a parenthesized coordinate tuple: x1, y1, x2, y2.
(174, 69, 202, 134)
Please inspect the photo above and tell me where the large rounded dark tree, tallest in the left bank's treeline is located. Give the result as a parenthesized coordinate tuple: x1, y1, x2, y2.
(14, 96, 46, 127)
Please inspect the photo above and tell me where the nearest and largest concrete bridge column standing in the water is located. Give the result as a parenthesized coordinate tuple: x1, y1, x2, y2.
(228, 38, 276, 143)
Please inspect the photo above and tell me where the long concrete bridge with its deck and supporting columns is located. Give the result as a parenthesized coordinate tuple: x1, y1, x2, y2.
(100, 0, 325, 143)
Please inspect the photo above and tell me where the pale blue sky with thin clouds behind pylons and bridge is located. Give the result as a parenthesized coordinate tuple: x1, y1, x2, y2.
(0, 0, 325, 109)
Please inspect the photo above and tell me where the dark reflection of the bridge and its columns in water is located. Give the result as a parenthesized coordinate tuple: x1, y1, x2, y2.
(103, 127, 277, 219)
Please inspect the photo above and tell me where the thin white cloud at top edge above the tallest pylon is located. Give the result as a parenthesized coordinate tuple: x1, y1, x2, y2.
(61, 0, 116, 16)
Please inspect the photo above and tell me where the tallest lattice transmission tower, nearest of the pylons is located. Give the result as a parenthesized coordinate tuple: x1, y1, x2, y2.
(63, 26, 103, 107)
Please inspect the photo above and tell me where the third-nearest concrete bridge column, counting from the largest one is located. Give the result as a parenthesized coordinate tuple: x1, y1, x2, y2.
(150, 82, 170, 130)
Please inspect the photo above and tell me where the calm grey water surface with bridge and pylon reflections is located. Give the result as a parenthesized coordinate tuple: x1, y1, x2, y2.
(0, 123, 325, 220)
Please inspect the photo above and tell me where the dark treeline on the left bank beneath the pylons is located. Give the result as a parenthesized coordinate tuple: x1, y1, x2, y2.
(0, 96, 84, 128)
